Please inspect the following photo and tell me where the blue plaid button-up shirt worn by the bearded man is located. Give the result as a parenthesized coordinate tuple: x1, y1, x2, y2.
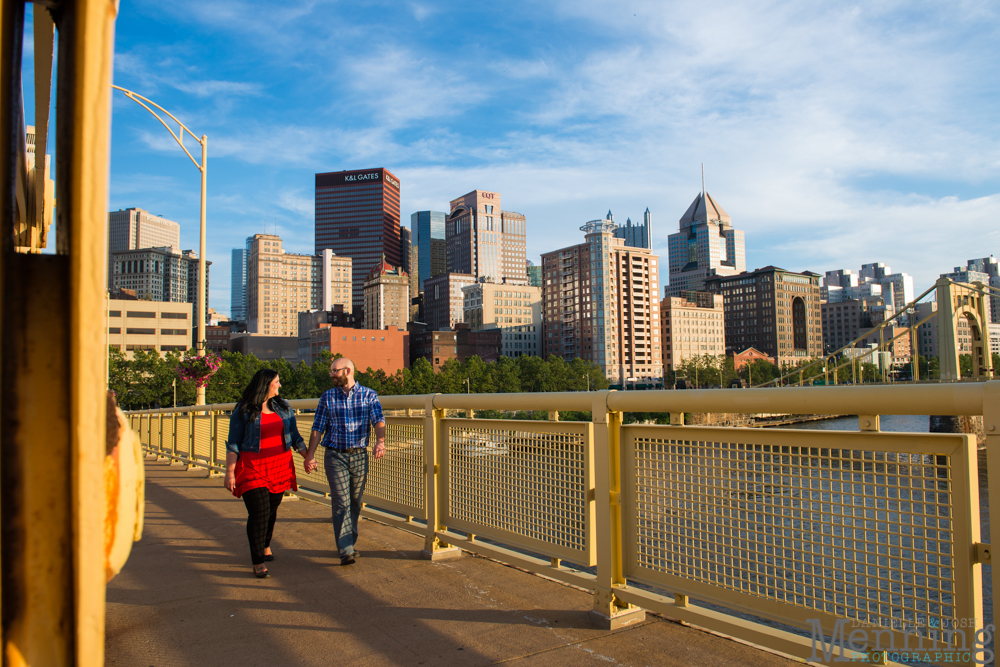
(312, 383, 385, 450)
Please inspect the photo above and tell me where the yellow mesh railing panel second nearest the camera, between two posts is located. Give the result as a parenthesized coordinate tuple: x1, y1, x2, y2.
(442, 419, 593, 565)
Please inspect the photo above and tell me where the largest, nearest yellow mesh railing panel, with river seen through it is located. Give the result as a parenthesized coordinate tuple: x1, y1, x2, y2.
(625, 428, 978, 634)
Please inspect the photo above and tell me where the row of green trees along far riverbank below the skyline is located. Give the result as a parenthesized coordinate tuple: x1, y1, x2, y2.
(108, 347, 1000, 417)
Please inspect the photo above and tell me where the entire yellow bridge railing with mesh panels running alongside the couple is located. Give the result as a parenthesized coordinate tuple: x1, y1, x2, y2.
(131, 381, 1000, 664)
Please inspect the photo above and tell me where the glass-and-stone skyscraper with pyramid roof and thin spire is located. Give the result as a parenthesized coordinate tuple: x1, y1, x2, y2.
(666, 191, 746, 296)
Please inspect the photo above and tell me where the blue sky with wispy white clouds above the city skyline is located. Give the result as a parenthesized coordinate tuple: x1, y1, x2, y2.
(23, 0, 1000, 312)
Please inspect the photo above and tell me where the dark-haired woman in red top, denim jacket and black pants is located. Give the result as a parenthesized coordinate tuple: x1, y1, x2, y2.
(225, 369, 306, 579)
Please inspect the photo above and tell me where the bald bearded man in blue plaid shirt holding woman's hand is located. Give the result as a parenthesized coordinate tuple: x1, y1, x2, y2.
(305, 357, 385, 565)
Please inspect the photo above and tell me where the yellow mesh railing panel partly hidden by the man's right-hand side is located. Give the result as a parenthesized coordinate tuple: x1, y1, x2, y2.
(365, 417, 426, 519)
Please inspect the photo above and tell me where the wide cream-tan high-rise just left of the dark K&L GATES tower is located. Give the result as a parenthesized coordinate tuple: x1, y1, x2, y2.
(247, 234, 352, 336)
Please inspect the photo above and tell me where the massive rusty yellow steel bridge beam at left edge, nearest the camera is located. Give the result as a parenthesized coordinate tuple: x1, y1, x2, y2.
(0, 0, 117, 666)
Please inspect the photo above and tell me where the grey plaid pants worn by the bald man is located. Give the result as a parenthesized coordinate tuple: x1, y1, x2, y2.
(323, 447, 368, 558)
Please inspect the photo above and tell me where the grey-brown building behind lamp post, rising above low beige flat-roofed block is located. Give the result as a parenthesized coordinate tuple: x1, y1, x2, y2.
(110, 247, 212, 312)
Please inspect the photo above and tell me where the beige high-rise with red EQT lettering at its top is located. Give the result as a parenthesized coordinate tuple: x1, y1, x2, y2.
(445, 190, 528, 285)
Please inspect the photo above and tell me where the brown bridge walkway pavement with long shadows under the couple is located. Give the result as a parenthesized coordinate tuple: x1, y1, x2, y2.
(106, 458, 794, 667)
